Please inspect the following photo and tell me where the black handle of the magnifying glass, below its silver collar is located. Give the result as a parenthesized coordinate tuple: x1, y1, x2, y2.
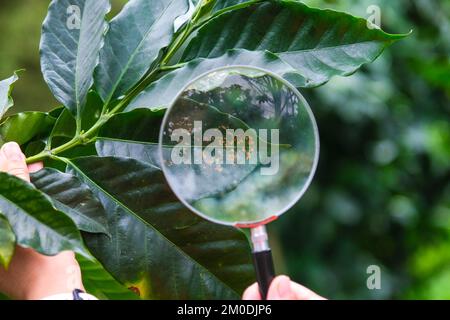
(253, 249, 275, 300)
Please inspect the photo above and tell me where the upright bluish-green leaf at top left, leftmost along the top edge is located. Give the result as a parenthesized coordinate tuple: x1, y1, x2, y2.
(40, 0, 110, 117)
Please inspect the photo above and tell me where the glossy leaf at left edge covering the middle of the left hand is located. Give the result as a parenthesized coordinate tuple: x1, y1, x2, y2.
(0, 172, 90, 258)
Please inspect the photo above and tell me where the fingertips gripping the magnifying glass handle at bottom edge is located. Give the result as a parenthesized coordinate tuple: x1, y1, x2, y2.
(242, 276, 325, 300)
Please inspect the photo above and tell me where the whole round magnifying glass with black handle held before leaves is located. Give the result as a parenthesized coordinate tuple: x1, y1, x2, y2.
(159, 66, 319, 299)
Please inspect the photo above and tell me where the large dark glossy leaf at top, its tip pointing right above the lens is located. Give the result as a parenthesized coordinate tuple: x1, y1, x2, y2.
(182, 1, 405, 87)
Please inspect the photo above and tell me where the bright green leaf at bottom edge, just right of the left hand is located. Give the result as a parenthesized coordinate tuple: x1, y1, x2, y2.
(77, 255, 139, 300)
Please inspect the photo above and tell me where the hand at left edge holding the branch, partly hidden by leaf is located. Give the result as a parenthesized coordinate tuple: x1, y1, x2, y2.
(0, 142, 84, 300)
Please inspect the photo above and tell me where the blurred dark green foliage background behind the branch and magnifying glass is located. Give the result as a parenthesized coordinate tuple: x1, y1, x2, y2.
(0, 0, 450, 299)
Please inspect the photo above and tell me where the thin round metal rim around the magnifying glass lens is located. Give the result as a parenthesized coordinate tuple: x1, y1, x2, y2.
(158, 65, 320, 228)
